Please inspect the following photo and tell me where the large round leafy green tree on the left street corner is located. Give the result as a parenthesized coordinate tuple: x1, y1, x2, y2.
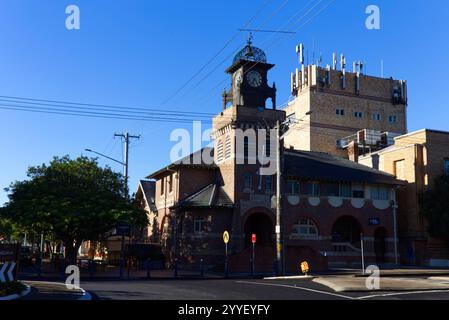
(0, 156, 148, 263)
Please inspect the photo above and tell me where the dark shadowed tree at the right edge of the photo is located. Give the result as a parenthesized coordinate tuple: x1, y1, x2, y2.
(420, 176, 449, 238)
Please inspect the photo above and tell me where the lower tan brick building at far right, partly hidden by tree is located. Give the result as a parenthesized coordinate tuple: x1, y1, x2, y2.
(358, 129, 449, 267)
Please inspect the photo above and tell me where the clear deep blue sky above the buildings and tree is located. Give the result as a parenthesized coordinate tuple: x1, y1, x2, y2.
(0, 0, 449, 205)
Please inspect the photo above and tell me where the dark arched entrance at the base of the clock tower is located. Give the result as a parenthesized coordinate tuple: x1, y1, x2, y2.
(245, 213, 274, 247)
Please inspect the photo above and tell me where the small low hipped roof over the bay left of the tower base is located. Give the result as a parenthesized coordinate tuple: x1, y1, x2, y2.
(172, 184, 234, 208)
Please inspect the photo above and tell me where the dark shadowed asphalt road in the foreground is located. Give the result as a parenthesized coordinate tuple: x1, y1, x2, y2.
(77, 279, 449, 301)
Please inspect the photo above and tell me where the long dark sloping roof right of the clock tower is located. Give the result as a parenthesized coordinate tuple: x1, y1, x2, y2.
(284, 150, 405, 185)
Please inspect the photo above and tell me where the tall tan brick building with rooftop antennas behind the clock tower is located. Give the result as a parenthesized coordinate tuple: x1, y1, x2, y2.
(285, 53, 407, 157)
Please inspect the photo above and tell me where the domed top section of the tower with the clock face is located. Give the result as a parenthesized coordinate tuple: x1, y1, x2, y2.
(223, 36, 276, 110)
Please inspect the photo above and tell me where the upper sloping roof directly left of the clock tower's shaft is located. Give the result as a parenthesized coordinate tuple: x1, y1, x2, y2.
(146, 147, 217, 179)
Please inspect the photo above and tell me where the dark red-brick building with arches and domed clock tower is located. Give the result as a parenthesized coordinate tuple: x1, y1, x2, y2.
(144, 41, 406, 272)
